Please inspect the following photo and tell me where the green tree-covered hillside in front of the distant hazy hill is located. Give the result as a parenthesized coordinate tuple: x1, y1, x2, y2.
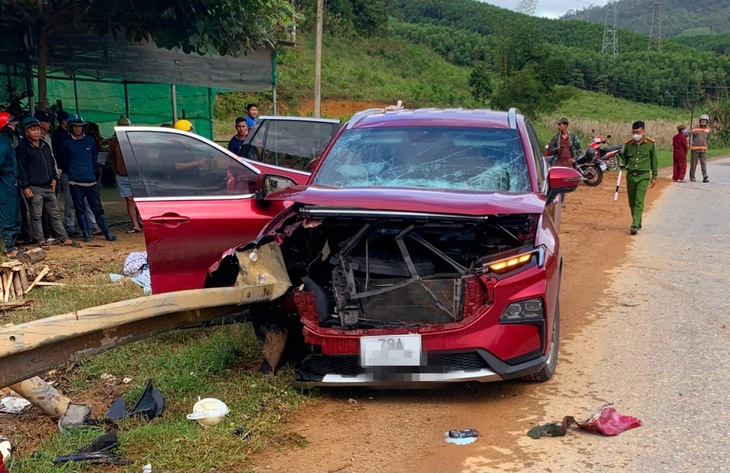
(390, 0, 730, 107)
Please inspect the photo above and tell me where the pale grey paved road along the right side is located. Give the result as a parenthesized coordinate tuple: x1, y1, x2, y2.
(484, 158, 730, 472)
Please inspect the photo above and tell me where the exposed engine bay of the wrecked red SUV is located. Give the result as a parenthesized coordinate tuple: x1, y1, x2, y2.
(259, 207, 537, 329)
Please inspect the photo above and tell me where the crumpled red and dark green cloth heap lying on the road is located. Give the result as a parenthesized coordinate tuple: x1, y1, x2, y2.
(527, 404, 641, 439)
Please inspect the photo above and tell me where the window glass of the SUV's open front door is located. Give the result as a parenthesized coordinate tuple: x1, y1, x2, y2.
(128, 131, 258, 197)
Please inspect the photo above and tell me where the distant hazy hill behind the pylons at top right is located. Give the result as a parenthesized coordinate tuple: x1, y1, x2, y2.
(561, 0, 730, 38)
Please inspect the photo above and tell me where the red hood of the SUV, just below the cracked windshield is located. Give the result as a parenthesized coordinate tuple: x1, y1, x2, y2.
(267, 186, 545, 216)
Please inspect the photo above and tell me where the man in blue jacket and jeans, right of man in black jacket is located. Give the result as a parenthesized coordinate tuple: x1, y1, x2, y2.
(61, 115, 117, 241)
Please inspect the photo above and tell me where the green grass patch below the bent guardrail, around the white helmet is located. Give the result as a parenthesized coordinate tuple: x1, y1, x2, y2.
(10, 324, 306, 473)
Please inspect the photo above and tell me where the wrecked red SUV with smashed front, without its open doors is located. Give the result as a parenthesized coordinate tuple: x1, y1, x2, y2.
(206, 109, 581, 386)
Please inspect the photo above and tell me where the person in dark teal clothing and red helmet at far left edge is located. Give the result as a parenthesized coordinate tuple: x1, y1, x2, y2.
(0, 112, 20, 258)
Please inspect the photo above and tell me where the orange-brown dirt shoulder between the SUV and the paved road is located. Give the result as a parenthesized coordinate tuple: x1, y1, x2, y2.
(252, 174, 676, 473)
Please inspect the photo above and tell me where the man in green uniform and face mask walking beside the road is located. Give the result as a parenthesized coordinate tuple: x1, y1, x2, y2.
(621, 121, 659, 235)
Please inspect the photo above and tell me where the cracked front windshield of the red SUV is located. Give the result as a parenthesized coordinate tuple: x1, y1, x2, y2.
(313, 127, 530, 193)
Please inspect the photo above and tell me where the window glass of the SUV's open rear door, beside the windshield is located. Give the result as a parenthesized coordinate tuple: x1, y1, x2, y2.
(246, 120, 335, 170)
